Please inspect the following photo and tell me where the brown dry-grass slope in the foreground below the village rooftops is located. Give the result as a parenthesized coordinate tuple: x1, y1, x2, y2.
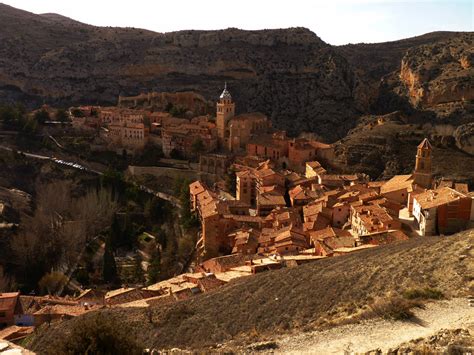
(27, 231, 474, 353)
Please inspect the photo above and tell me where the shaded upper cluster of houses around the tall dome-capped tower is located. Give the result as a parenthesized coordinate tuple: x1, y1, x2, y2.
(70, 87, 332, 163)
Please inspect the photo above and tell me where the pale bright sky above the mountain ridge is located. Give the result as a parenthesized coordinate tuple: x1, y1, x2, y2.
(0, 0, 474, 45)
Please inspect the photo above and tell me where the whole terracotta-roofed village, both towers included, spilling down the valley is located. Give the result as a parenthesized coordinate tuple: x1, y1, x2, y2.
(0, 87, 474, 340)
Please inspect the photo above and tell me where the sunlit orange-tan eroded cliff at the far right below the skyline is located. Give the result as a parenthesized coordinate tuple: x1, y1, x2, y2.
(400, 33, 474, 108)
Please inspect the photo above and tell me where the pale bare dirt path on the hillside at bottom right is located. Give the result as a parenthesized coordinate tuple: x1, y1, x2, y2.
(275, 298, 474, 354)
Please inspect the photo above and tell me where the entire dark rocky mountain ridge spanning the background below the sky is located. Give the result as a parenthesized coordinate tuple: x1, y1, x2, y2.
(0, 4, 473, 141)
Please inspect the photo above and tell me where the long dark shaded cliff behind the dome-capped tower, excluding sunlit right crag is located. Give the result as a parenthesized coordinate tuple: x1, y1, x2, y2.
(0, 5, 360, 140)
